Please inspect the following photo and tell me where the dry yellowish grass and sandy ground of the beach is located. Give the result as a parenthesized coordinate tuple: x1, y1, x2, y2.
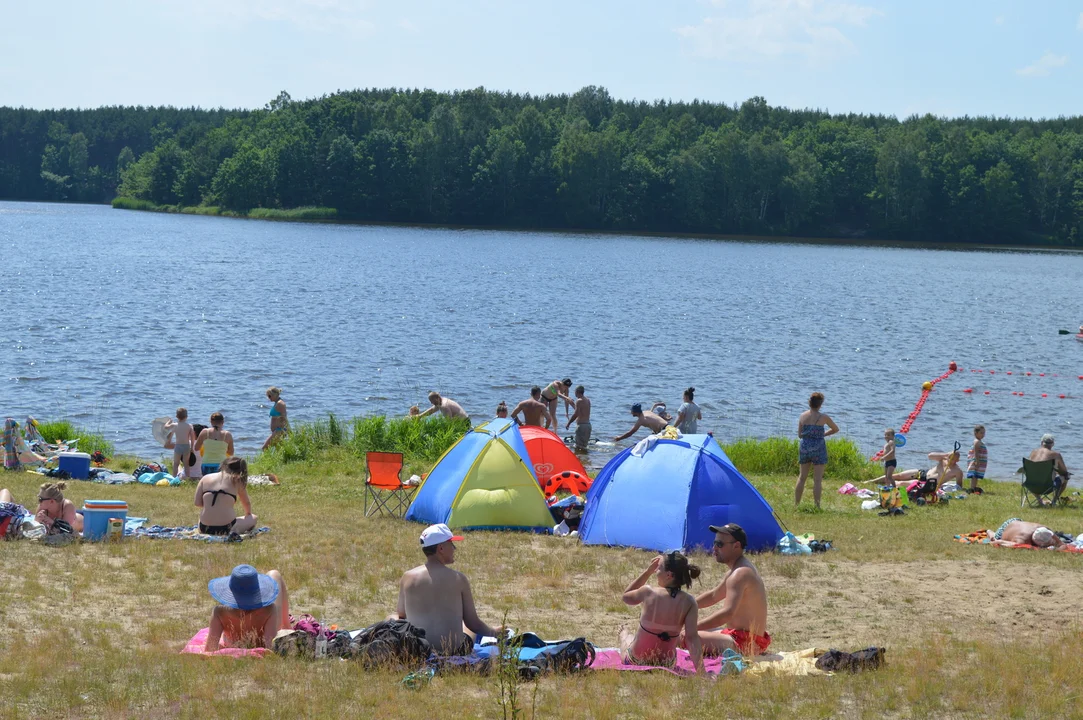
(0, 459, 1083, 719)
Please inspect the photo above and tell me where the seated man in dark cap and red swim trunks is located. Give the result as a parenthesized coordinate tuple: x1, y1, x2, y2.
(681, 523, 771, 656)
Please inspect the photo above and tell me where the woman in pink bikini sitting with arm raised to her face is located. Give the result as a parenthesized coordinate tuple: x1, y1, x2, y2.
(619, 552, 704, 675)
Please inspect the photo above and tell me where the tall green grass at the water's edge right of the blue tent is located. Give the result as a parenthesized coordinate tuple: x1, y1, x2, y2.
(722, 437, 882, 482)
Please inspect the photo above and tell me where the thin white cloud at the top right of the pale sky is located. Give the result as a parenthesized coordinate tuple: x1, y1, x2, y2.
(676, 0, 883, 62)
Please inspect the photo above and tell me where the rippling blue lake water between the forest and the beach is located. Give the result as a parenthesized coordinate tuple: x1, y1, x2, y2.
(0, 202, 1083, 476)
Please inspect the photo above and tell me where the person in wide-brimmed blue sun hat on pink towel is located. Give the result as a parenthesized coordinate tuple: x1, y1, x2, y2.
(204, 565, 292, 653)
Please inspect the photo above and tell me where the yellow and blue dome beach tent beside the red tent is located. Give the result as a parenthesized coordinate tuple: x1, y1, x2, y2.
(406, 418, 552, 532)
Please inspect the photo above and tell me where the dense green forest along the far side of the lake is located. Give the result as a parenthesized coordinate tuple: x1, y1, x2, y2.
(6, 87, 1083, 245)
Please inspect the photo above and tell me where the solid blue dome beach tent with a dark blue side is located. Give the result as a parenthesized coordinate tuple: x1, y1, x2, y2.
(579, 435, 783, 552)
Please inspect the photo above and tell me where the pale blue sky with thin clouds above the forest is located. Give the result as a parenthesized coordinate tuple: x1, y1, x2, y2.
(0, 0, 1083, 118)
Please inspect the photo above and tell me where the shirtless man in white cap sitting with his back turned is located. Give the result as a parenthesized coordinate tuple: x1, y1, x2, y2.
(392, 523, 499, 655)
